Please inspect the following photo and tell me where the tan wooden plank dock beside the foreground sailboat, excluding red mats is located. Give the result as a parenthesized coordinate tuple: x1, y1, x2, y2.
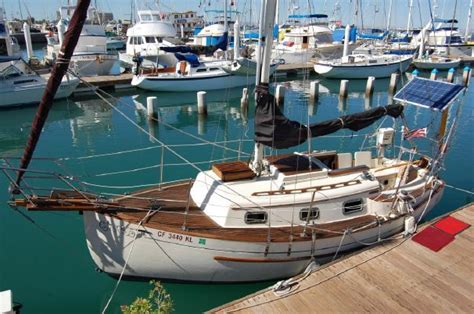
(209, 203, 474, 313)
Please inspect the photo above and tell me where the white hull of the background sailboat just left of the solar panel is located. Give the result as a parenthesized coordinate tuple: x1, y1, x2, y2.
(314, 58, 412, 79)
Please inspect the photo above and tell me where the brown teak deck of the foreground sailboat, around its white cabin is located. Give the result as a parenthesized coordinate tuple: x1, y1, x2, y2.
(110, 181, 377, 242)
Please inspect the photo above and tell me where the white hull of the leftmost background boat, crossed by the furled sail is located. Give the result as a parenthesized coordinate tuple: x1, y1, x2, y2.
(0, 78, 79, 108)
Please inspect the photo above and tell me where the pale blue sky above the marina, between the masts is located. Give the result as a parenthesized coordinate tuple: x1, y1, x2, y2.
(0, 0, 474, 30)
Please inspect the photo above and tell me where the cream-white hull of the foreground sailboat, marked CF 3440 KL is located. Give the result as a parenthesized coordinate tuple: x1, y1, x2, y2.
(84, 188, 443, 282)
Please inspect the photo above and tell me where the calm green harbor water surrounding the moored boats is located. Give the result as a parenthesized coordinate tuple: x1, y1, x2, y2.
(0, 72, 474, 313)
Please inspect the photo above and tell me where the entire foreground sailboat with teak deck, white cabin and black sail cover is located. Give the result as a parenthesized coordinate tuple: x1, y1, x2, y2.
(3, 0, 464, 282)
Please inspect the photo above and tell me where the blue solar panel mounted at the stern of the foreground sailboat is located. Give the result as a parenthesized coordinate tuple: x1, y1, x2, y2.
(393, 77, 464, 111)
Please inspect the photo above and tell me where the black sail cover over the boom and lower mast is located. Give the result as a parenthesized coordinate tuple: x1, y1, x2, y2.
(255, 85, 403, 149)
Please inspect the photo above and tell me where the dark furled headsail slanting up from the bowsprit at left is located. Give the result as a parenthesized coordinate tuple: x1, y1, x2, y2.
(11, 0, 91, 193)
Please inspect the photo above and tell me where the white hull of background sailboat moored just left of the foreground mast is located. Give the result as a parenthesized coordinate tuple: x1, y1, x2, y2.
(132, 73, 255, 92)
